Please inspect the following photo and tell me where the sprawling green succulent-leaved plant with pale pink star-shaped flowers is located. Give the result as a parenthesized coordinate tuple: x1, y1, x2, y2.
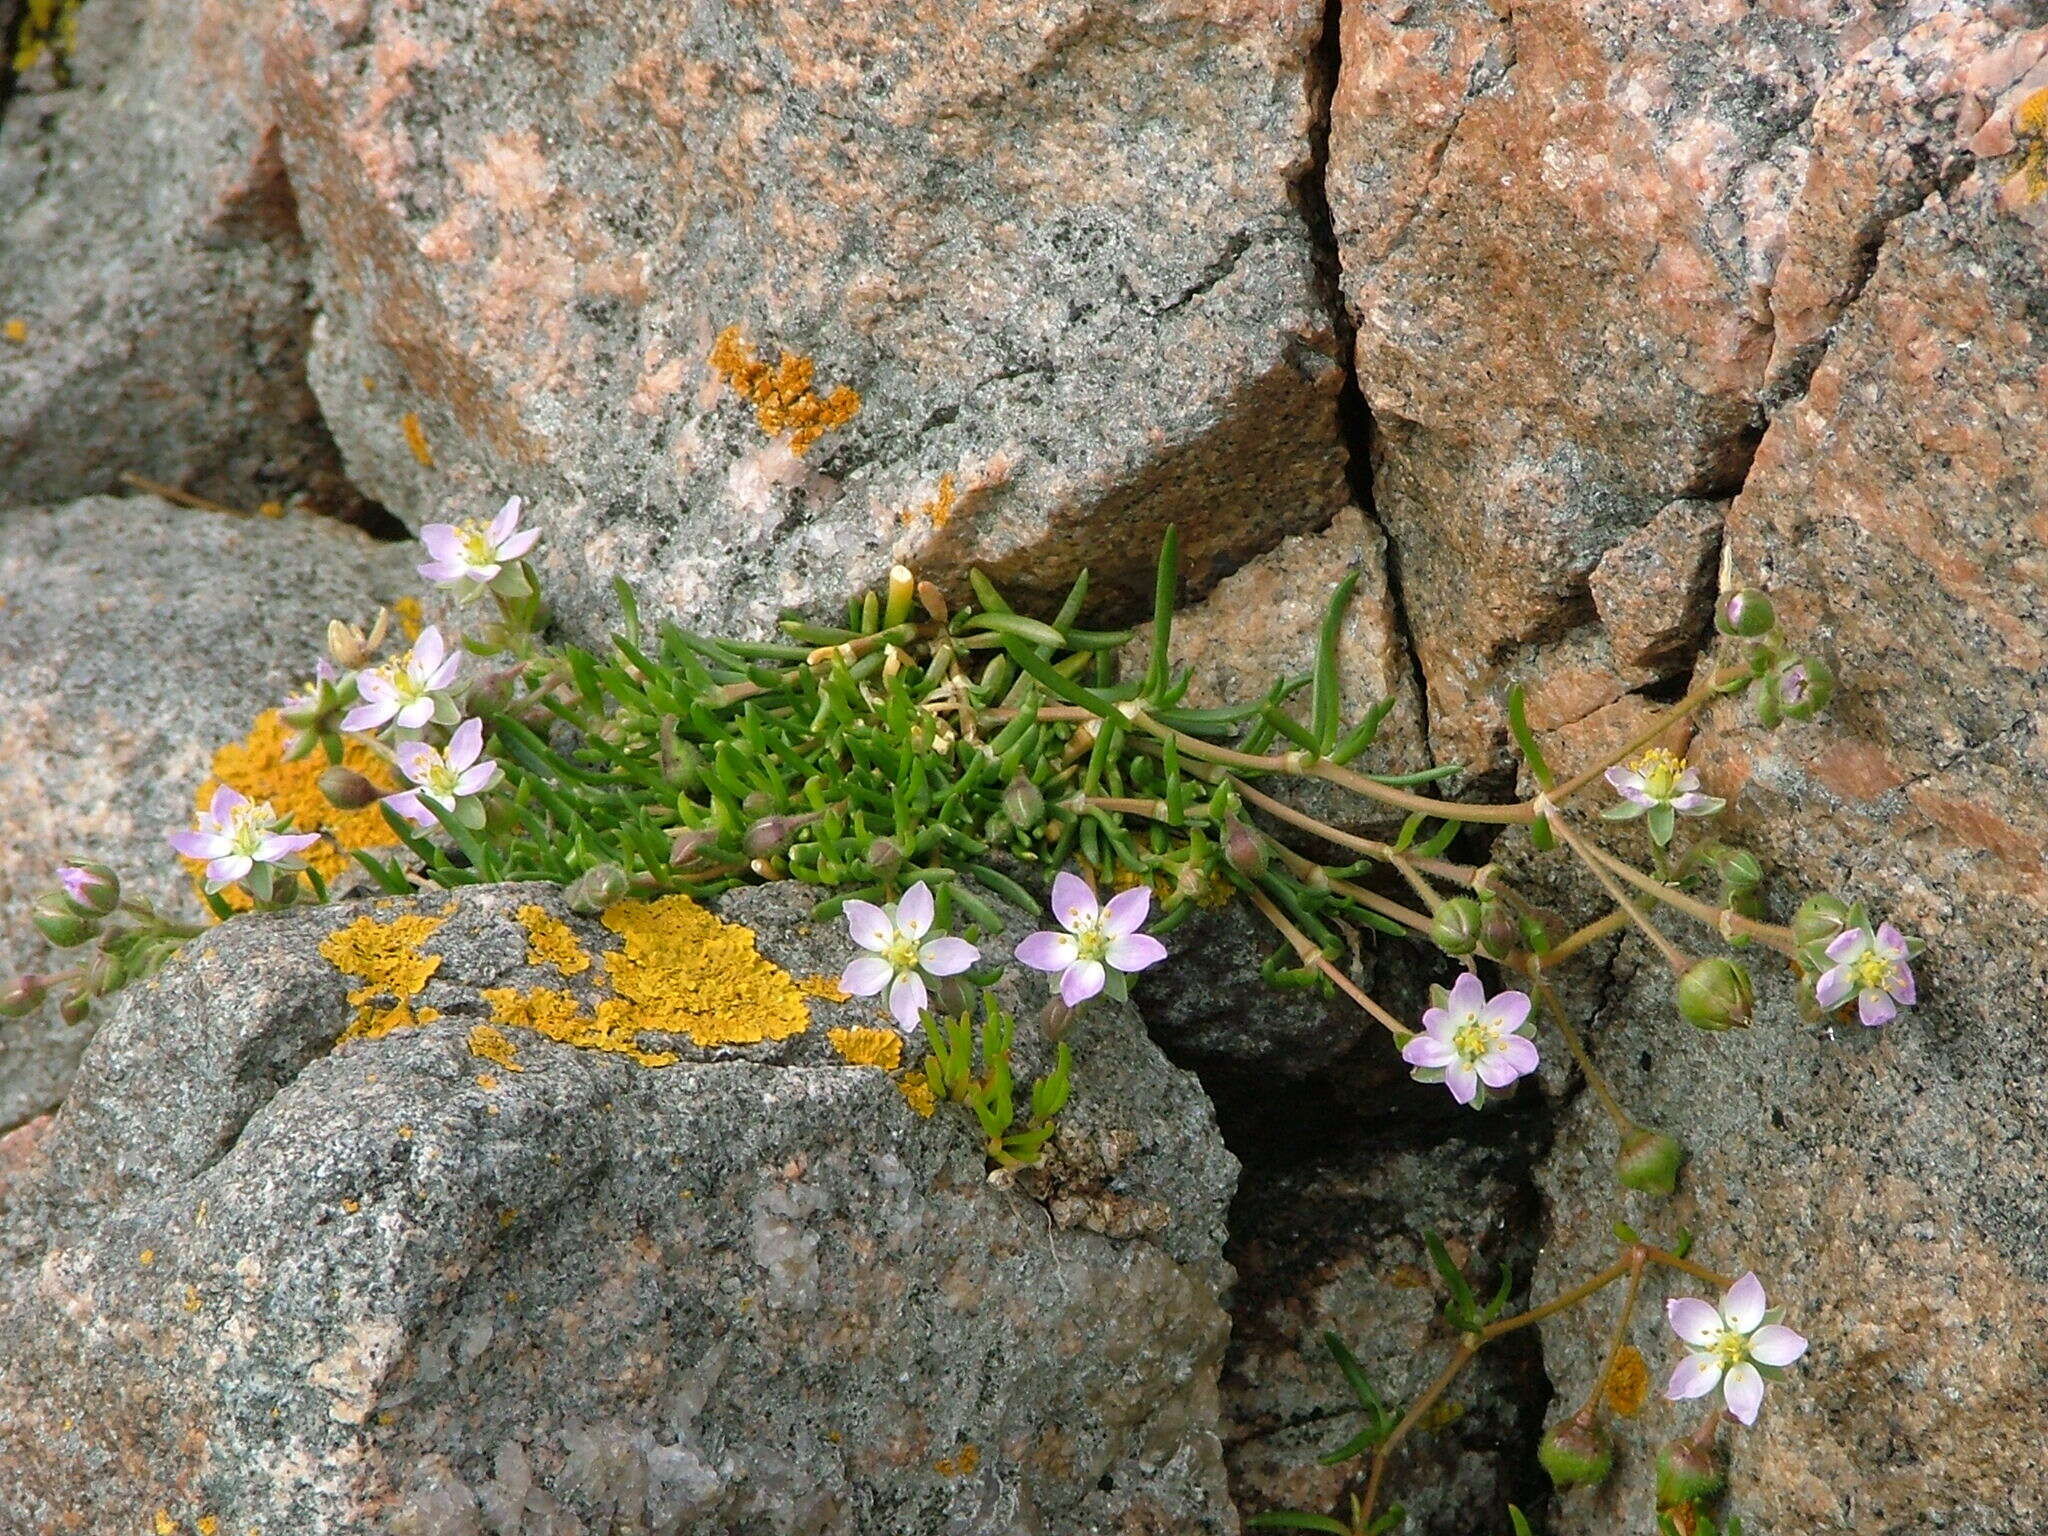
(0, 498, 1919, 1536)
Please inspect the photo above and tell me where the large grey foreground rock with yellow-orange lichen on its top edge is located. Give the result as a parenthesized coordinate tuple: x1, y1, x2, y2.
(0, 887, 1237, 1536)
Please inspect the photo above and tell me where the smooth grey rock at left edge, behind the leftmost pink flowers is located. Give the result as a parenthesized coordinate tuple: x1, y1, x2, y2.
(0, 498, 418, 1126)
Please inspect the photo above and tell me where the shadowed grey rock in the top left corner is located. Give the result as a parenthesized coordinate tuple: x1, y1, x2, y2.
(0, 0, 358, 510)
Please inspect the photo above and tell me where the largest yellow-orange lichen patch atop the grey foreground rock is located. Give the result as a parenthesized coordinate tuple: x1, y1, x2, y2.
(598, 895, 811, 1044)
